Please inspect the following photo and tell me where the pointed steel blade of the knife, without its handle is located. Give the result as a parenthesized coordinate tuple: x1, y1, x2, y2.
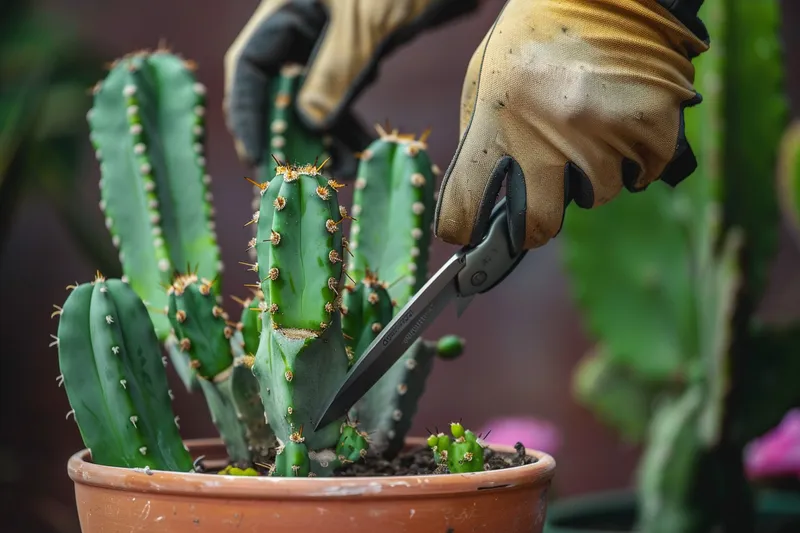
(315, 251, 464, 430)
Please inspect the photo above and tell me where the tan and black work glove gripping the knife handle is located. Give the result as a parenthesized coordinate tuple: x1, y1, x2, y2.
(434, 0, 708, 249)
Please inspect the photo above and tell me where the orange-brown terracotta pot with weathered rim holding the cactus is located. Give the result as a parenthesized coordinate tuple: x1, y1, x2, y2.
(68, 439, 555, 533)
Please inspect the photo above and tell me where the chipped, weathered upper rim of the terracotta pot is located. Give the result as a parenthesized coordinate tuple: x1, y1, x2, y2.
(67, 437, 556, 500)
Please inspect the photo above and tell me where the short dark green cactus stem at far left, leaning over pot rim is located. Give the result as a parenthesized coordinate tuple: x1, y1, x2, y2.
(57, 273, 193, 472)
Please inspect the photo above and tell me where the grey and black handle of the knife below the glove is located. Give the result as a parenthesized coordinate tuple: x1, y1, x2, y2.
(457, 198, 528, 297)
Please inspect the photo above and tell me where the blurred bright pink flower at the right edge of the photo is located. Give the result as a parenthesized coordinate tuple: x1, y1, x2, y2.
(745, 409, 800, 479)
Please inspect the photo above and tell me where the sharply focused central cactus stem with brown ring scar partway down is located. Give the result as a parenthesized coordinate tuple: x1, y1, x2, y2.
(250, 163, 348, 450)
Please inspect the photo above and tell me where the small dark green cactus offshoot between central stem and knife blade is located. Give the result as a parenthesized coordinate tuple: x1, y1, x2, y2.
(341, 269, 394, 365)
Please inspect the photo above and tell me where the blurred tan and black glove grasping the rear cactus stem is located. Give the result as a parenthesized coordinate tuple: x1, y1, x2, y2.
(223, 0, 478, 177)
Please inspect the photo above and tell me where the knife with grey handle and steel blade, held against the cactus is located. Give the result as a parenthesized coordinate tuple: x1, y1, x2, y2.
(314, 198, 527, 430)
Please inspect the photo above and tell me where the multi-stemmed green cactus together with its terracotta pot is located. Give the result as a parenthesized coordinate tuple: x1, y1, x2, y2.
(53, 48, 554, 533)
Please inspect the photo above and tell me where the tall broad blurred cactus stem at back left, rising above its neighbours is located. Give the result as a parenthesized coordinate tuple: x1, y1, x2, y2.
(87, 49, 222, 341)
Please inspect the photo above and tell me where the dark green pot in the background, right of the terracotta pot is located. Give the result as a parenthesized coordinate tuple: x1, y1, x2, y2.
(544, 489, 800, 533)
